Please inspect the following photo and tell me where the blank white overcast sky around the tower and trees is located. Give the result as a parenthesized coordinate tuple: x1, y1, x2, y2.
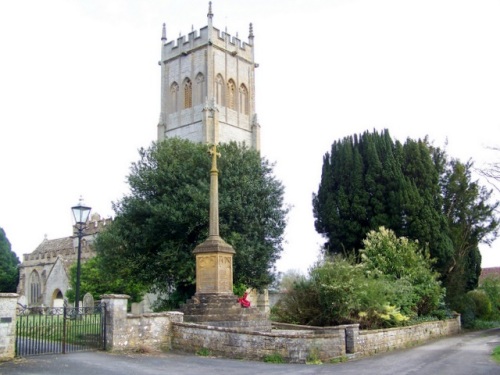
(0, 0, 500, 272)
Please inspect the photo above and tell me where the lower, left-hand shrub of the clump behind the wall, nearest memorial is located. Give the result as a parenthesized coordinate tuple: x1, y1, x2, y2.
(273, 256, 410, 328)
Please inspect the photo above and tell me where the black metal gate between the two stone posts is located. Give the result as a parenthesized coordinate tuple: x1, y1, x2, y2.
(16, 303, 106, 357)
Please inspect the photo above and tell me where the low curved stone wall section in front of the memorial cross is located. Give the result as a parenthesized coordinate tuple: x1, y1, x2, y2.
(172, 323, 346, 363)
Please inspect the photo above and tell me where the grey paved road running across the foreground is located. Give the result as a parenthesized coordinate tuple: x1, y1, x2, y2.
(0, 329, 500, 375)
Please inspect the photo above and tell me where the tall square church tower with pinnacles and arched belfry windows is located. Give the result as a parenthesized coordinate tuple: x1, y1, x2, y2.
(158, 2, 260, 150)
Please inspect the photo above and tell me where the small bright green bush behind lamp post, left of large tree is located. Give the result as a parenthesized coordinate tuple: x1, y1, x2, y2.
(66, 255, 147, 303)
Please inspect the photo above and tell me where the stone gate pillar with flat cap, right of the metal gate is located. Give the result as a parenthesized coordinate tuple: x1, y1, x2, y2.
(101, 294, 130, 351)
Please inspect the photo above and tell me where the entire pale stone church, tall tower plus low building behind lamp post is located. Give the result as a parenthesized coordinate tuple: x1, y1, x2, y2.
(17, 2, 260, 307)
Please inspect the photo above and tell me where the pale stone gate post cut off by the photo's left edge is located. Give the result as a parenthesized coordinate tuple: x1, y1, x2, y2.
(0, 293, 19, 362)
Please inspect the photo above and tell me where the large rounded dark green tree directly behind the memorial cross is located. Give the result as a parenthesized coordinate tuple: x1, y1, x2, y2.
(96, 138, 288, 305)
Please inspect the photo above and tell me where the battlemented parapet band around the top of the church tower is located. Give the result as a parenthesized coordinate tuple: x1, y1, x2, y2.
(161, 26, 253, 62)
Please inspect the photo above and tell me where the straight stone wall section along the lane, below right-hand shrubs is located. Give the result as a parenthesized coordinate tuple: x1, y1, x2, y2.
(356, 315, 461, 357)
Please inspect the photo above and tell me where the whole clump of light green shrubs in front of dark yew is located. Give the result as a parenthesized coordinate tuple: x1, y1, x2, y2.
(273, 227, 444, 328)
